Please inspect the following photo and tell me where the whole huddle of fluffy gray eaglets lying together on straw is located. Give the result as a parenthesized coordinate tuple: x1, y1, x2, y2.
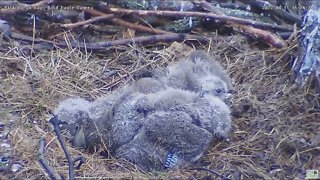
(55, 51, 232, 171)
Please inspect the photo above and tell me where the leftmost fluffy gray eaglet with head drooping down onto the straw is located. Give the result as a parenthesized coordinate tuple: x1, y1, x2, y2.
(55, 78, 164, 150)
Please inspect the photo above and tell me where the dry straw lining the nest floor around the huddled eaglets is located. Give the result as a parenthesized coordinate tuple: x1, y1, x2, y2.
(0, 36, 320, 179)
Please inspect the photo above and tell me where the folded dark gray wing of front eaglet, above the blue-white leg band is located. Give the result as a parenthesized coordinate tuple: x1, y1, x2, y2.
(116, 111, 212, 171)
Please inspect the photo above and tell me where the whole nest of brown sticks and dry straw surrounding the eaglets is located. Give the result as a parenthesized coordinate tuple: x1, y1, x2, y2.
(0, 0, 320, 179)
